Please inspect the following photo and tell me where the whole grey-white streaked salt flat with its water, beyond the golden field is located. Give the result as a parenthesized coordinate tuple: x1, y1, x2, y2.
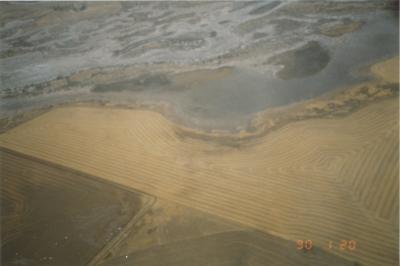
(0, 1, 398, 128)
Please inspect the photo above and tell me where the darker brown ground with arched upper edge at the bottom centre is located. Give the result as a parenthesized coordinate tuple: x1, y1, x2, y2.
(102, 231, 355, 266)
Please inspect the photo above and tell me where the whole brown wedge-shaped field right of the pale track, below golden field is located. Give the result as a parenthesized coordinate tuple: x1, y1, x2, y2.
(100, 195, 354, 266)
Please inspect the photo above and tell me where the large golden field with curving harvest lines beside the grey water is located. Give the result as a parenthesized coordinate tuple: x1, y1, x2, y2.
(0, 94, 398, 265)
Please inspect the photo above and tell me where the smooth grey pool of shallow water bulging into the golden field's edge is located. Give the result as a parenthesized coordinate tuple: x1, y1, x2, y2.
(133, 10, 398, 128)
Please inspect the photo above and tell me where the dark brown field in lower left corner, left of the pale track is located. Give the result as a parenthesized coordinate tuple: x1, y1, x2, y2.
(0, 148, 151, 266)
